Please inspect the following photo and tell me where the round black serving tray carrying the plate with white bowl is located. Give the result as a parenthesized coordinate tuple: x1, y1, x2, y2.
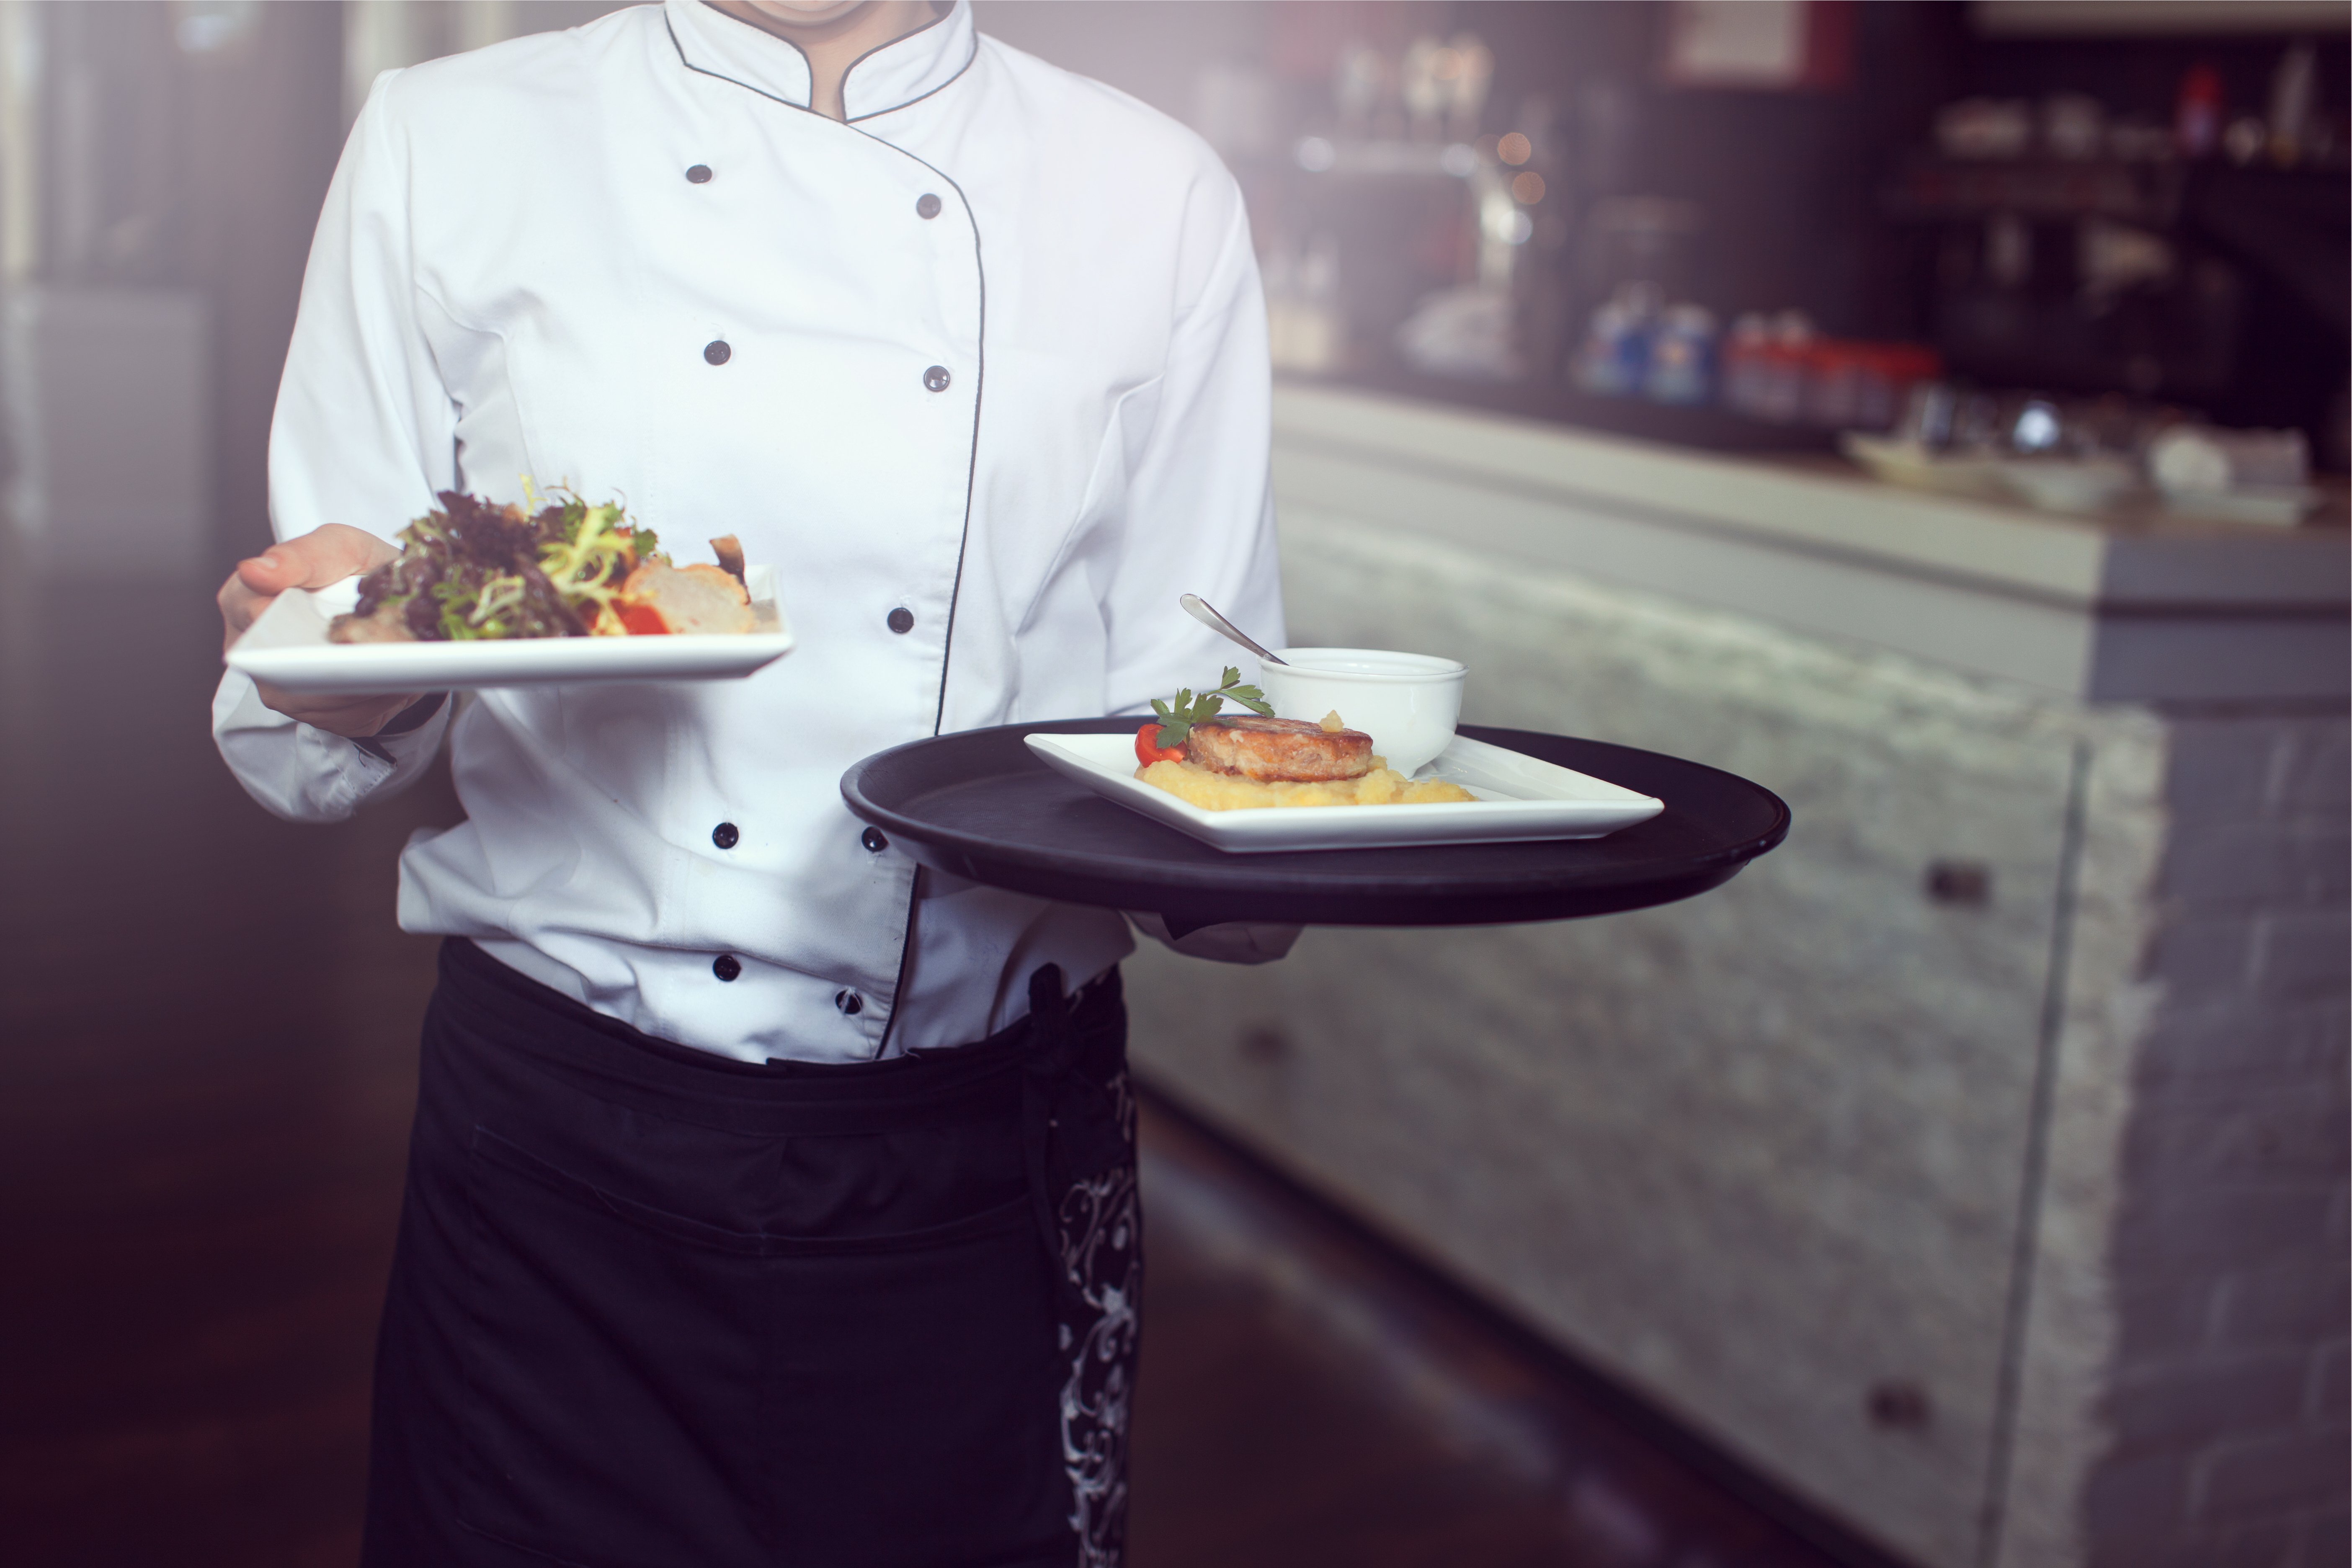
(842, 720, 1787, 936)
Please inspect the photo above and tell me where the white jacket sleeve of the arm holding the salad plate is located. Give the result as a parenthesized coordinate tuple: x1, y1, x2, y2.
(211, 70, 456, 823)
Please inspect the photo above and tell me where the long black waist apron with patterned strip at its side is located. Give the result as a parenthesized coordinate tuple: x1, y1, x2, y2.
(362, 940, 1141, 1568)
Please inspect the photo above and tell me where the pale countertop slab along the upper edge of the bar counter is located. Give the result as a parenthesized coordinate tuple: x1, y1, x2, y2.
(1275, 386, 2352, 701)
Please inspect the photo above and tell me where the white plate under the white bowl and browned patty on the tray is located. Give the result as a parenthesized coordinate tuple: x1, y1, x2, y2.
(1023, 736, 1665, 854)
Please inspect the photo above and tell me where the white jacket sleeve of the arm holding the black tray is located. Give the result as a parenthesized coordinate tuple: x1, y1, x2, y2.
(1103, 169, 1287, 712)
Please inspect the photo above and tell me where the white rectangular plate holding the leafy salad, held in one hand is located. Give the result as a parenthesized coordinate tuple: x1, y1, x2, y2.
(228, 567, 793, 694)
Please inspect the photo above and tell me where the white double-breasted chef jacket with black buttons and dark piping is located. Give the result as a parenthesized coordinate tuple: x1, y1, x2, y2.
(214, 0, 1282, 1060)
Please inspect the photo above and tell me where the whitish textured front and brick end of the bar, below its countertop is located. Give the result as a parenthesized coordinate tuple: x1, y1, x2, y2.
(1129, 503, 2347, 1568)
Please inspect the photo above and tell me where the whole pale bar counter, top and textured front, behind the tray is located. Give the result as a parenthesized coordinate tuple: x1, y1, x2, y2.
(1129, 386, 2347, 1568)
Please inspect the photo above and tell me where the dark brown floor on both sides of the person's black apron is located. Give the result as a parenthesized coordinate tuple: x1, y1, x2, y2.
(0, 578, 1872, 1568)
